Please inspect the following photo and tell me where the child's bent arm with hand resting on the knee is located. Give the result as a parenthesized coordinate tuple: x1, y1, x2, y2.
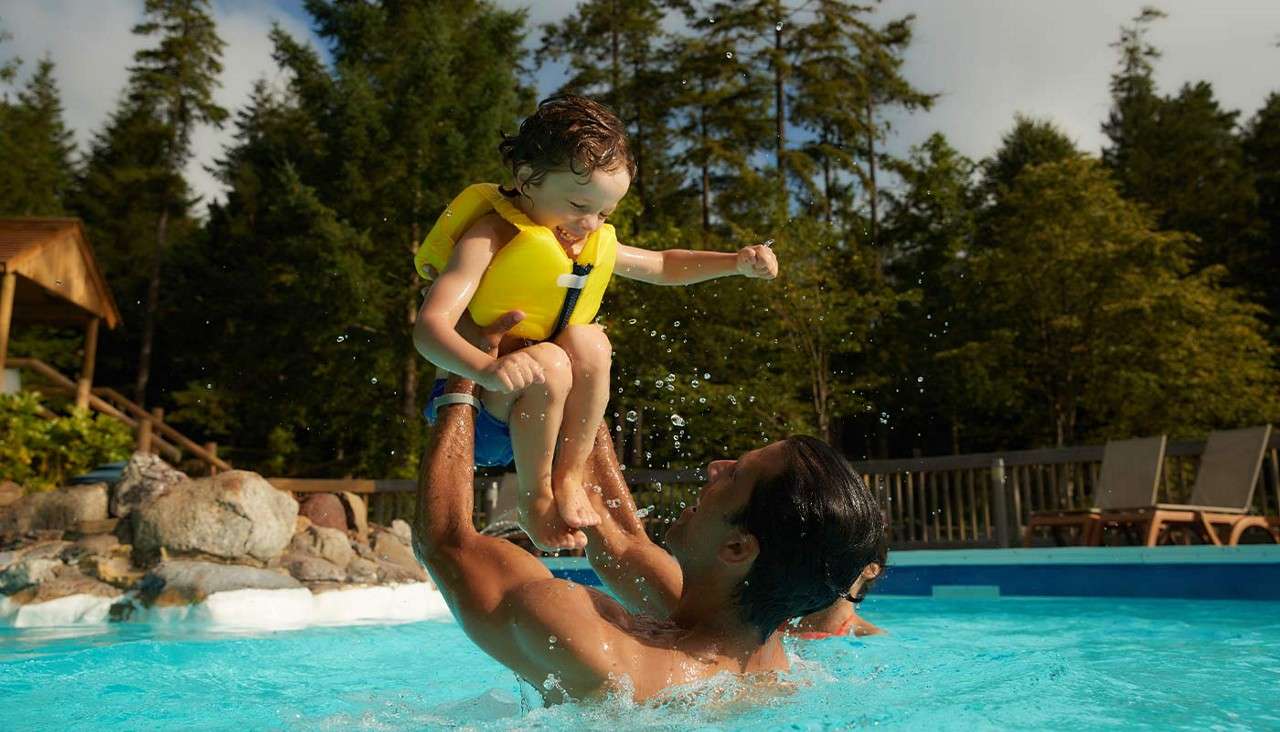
(413, 219, 543, 393)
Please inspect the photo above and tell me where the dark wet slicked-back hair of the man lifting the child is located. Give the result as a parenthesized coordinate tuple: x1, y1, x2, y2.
(730, 435, 884, 641)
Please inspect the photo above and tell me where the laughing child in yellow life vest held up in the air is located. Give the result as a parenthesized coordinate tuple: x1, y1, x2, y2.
(413, 95, 778, 549)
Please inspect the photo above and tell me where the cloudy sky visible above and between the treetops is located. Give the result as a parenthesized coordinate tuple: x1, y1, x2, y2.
(0, 0, 1280, 206)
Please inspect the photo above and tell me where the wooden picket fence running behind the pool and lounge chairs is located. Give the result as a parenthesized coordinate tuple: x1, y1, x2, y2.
(282, 435, 1280, 549)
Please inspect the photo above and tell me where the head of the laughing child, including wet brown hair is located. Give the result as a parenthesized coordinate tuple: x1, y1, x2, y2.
(498, 95, 636, 246)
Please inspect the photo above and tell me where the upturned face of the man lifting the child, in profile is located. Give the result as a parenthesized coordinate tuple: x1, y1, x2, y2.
(667, 443, 783, 572)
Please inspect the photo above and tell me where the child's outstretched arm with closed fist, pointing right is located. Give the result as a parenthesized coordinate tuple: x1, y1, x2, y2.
(614, 244, 778, 285)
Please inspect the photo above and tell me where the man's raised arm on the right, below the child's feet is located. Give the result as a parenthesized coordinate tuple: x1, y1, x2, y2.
(584, 425, 684, 618)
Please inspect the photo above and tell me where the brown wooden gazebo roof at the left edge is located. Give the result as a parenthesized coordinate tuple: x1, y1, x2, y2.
(0, 219, 120, 329)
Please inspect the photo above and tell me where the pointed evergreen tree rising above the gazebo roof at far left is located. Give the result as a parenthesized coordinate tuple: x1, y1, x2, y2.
(0, 58, 76, 216)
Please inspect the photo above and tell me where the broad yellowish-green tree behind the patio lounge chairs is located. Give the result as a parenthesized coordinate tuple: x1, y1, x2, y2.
(950, 157, 1276, 445)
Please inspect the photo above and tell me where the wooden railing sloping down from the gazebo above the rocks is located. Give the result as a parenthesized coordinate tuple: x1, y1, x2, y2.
(8, 358, 232, 473)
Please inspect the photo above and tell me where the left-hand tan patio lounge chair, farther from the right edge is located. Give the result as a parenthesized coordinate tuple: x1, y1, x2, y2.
(1023, 435, 1167, 546)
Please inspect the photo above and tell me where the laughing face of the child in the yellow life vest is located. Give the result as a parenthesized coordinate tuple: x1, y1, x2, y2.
(521, 168, 631, 247)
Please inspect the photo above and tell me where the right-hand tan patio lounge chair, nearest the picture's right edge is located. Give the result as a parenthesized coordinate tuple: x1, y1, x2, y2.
(1098, 425, 1276, 546)
